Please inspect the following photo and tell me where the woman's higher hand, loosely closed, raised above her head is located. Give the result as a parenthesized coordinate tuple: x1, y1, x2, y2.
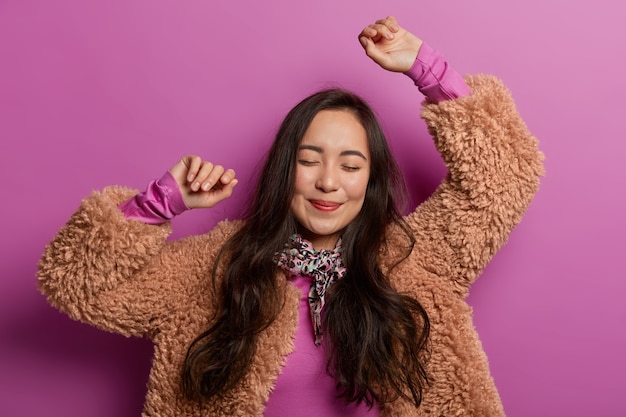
(359, 16, 422, 72)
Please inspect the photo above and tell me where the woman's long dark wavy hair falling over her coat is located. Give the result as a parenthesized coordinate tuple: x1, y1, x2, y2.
(178, 89, 430, 406)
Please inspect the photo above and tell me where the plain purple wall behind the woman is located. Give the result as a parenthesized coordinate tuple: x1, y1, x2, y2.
(0, 0, 626, 417)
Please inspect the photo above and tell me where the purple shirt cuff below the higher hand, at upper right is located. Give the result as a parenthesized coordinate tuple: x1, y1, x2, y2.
(405, 43, 471, 103)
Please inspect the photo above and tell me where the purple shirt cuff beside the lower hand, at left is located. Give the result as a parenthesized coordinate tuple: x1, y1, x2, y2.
(119, 171, 189, 224)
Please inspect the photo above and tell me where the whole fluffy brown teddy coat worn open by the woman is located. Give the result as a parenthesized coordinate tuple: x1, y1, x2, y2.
(38, 75, 543, 417)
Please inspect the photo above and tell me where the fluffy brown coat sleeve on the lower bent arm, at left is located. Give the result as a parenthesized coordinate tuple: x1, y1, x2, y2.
(38, 187, 234, 337)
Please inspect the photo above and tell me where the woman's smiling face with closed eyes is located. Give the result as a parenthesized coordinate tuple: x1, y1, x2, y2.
(291, 110, 370, 250)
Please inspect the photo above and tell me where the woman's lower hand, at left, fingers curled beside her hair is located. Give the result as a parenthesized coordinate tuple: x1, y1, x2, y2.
(170, 155, 239, 208)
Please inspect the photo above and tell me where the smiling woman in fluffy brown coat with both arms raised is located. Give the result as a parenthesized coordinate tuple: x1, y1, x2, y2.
(39, 17, 543, 416)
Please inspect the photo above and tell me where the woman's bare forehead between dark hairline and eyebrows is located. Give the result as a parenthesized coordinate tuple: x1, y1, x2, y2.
(301, 110, 369, 154)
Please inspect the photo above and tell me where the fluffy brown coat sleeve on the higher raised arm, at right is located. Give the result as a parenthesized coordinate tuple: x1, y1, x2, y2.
(407, 75, 544, 296)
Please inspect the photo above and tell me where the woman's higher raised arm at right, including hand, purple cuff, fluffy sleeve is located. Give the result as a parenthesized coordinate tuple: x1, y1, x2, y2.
(359, 17, 543, 296)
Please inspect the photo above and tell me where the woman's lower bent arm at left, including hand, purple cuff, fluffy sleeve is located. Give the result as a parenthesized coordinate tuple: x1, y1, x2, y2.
(38, 157, 236, 335)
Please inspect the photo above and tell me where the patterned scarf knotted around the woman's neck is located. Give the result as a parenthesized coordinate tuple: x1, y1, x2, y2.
(275, 234, 346, 346)
